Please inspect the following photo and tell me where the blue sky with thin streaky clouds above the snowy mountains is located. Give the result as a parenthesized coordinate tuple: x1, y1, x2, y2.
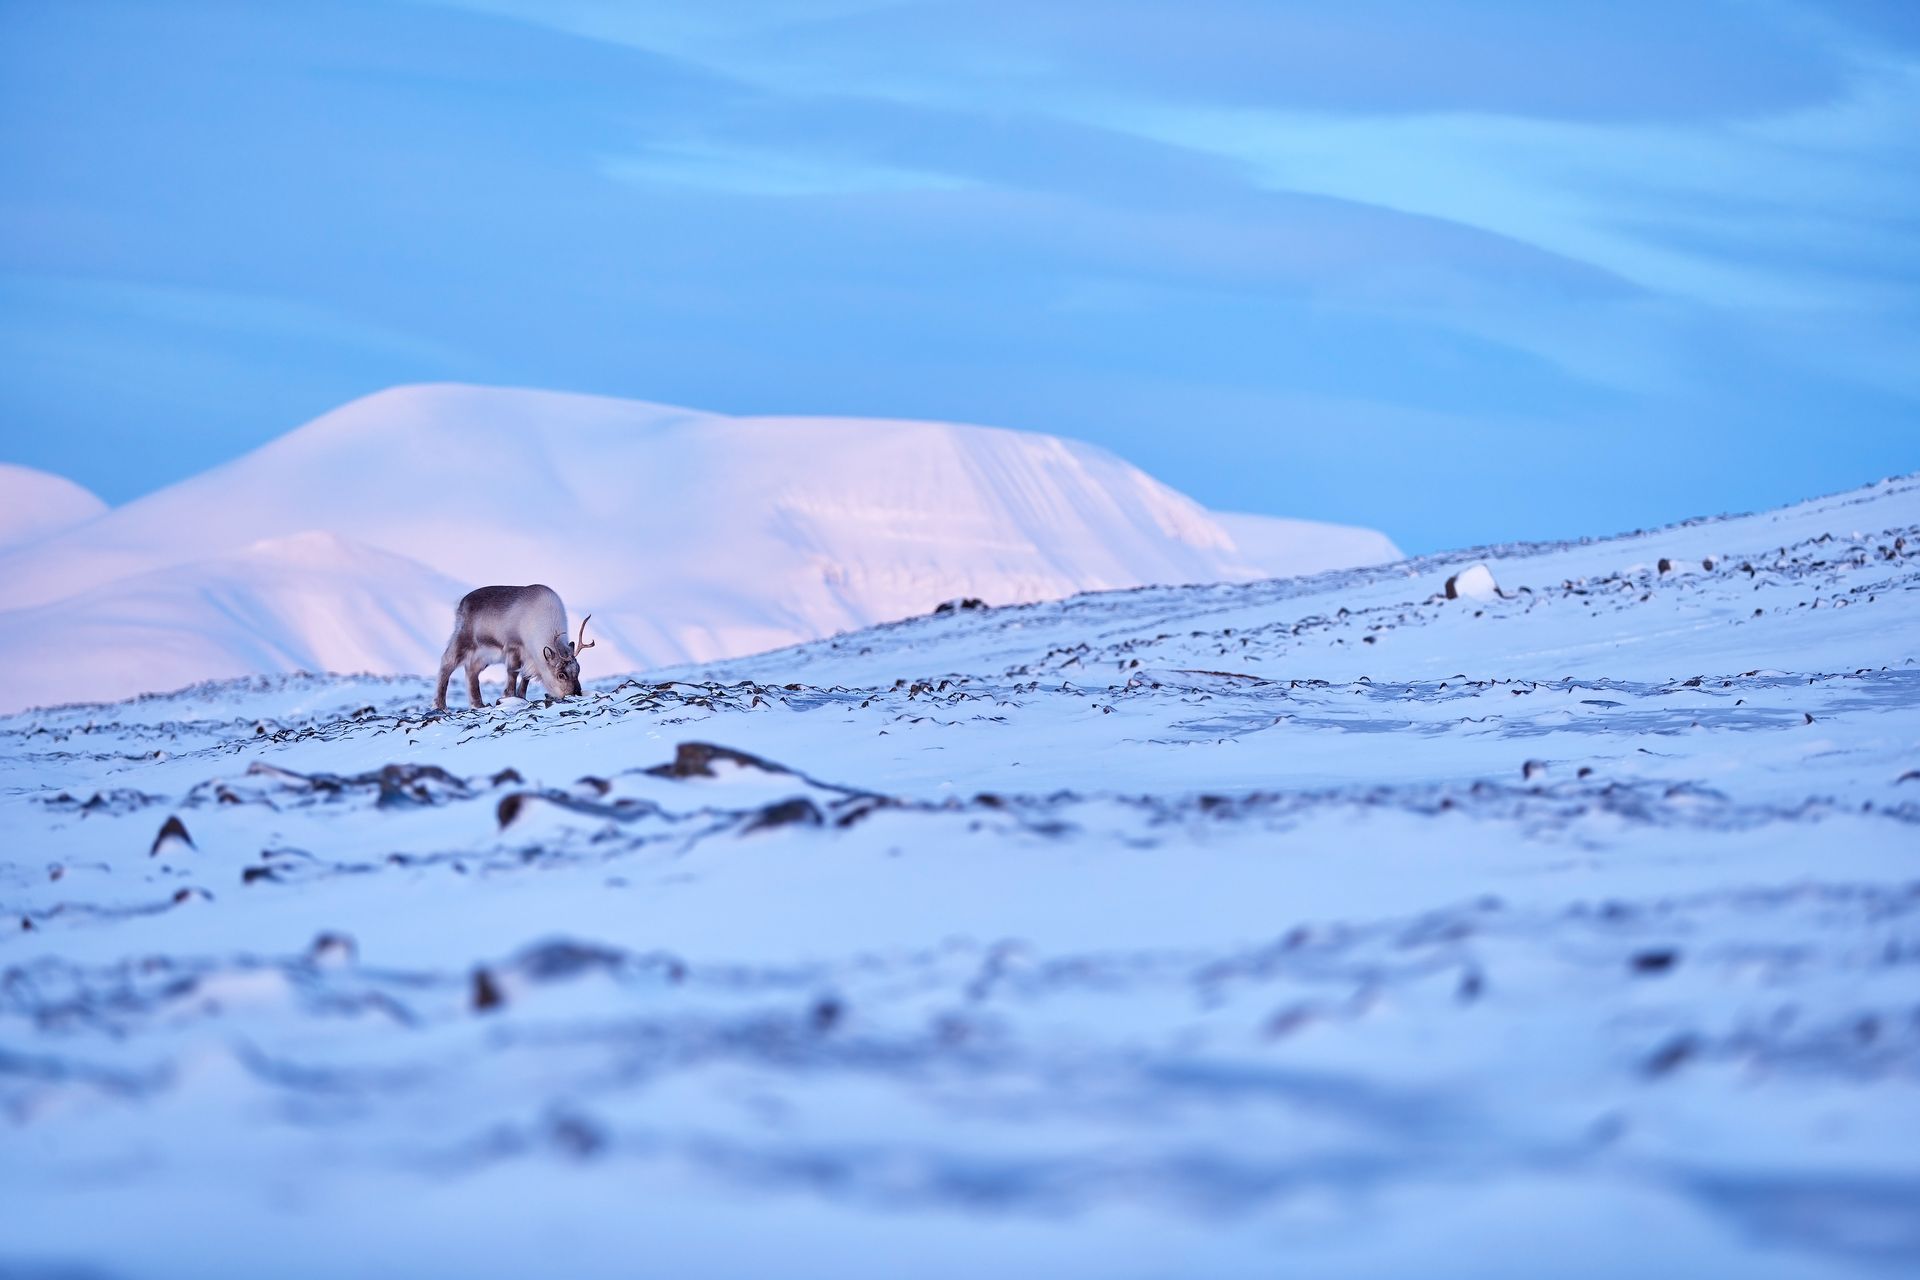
(0, 0, 1920, 551)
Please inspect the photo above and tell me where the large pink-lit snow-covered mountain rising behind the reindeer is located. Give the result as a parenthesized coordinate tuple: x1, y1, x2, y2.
(0, 386, 1396, 710)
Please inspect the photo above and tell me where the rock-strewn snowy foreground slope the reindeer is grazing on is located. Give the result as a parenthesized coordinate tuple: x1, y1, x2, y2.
(0, 478, 1920, 1278)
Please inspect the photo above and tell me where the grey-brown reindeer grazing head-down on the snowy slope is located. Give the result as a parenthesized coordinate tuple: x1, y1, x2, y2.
(434, 583, 597, 712)
